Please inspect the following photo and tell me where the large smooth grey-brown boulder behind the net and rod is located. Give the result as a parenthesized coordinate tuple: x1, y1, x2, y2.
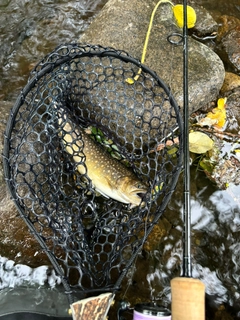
(79, 0, 225, 113)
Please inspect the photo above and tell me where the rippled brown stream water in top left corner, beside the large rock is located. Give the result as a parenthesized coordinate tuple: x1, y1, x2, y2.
(0, 0, 107, 99)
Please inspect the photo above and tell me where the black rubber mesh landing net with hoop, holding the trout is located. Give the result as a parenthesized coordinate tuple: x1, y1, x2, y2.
(4, 44, 182, 302)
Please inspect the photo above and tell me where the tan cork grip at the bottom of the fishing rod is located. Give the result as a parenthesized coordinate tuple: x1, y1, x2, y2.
(171, 277, 205, 320)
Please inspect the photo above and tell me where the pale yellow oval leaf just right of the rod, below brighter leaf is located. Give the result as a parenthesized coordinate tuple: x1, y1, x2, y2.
(189, 131, 214, 154)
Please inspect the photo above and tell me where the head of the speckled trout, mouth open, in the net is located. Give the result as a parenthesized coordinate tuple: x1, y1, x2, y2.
(118, 176, 147, 208)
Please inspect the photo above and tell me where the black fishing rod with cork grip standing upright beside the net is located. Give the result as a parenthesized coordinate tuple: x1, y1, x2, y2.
(171, 0, 205, 320)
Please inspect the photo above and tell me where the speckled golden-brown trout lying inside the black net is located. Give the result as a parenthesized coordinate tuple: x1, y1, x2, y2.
(59, 112, 147, 208)
